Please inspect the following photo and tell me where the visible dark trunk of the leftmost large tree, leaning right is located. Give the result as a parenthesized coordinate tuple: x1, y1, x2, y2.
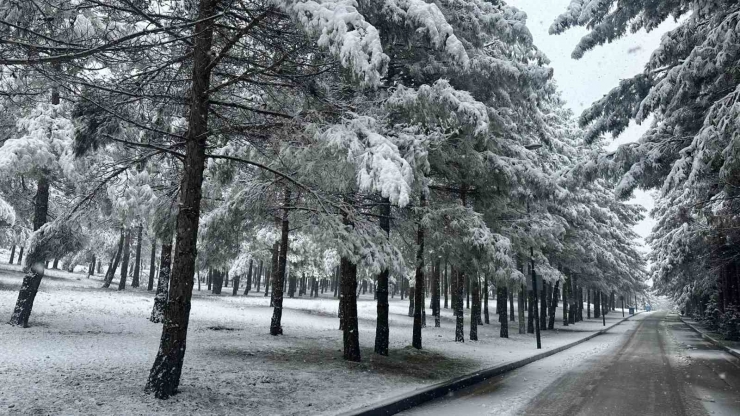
(9, 173, 49, 328)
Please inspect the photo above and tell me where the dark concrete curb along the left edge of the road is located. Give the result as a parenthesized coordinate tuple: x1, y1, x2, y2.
(339, 312, 642, 416)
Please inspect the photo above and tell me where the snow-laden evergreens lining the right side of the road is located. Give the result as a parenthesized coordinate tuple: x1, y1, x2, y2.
(550, 1, 740, 333)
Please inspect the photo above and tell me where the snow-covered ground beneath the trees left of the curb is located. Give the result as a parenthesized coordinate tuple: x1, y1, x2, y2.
(0, 264, 632, 415)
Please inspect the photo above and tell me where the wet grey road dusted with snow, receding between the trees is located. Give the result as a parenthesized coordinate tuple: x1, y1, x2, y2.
(403, 312, 740, 416)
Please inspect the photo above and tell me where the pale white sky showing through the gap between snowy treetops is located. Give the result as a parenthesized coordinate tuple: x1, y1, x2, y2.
(507, 0, 676, 250)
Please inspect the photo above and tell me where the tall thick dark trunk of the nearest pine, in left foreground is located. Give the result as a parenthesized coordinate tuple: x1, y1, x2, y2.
(146, 0, 219, 399)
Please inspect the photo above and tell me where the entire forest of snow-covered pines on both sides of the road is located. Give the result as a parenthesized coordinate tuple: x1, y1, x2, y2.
(0, 0, 740, 404)
